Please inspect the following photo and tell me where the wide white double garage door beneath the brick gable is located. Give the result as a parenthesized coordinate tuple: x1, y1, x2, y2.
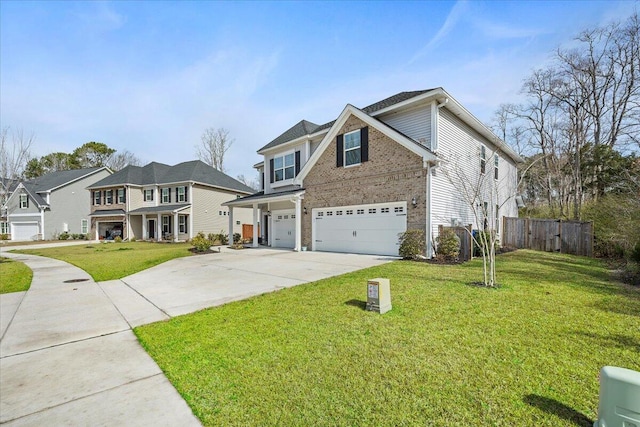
(312, 202, 407, 256)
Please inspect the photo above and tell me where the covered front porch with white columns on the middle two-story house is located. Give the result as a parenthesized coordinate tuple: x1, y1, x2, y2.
(129, 204, 193, 242)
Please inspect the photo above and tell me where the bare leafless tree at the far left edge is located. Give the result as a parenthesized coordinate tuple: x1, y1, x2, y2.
(0, 128, 35, 196)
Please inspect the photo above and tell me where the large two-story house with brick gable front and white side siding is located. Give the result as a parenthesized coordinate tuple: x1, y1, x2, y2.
(226, 88, 522, 257)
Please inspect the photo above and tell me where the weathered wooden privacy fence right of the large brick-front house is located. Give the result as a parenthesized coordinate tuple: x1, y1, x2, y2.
(501, 217, 593, 257)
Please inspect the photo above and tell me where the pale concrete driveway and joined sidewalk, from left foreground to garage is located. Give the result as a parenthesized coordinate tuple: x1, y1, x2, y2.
(0, 246, 391, 426)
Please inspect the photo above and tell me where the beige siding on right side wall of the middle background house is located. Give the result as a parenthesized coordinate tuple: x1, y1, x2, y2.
(191, 185, 253, 235)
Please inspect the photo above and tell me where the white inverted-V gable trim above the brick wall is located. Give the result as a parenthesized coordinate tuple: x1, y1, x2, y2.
(293, 104, 437, 185)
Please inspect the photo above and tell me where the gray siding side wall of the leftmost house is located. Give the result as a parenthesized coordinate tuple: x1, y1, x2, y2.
(44, 169, 110, 239)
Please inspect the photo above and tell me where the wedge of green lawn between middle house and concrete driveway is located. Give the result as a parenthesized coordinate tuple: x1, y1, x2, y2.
(16, 242, 191, 282)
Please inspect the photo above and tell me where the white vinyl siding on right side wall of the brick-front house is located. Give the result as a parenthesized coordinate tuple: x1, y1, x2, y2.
(431, 108, 518, 241)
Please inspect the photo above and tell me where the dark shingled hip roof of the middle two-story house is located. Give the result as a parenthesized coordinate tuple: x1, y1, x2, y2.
(87, 160, 254, 194)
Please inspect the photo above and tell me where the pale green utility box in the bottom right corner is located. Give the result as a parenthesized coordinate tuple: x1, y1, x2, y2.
(593, 366, 640, 427)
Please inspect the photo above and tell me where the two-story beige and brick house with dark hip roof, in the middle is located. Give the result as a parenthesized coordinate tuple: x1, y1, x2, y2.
(87, 160, 254, 241)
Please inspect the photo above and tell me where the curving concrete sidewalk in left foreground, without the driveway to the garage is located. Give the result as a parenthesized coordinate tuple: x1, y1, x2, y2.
(0, 252, 200, 426)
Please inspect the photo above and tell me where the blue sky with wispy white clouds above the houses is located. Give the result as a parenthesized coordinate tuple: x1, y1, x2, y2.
(0, 1, 640, 181)
